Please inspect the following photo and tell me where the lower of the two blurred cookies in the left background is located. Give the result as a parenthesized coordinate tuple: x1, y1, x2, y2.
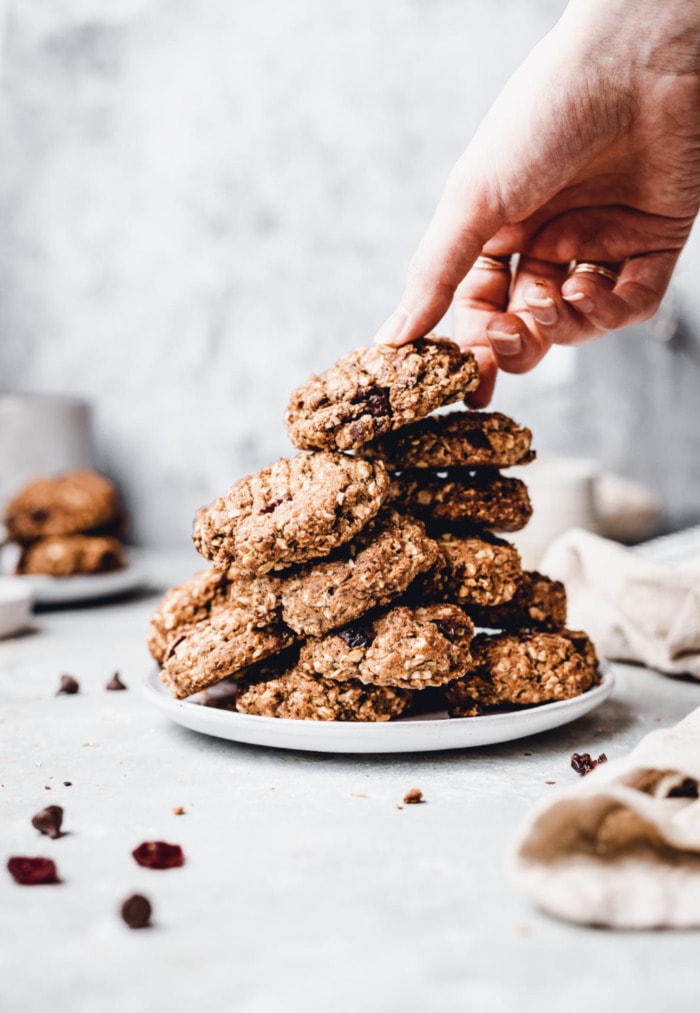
(16, 535, 127, 576)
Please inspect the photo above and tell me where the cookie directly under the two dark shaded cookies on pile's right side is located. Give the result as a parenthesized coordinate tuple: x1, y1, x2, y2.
(409, 532, 523, 618)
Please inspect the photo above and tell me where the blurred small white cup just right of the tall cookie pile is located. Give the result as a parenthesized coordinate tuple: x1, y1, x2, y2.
(505, 454, 600, 569)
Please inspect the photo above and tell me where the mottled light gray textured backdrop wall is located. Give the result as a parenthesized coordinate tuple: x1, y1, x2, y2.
(0, 0, 700, 543)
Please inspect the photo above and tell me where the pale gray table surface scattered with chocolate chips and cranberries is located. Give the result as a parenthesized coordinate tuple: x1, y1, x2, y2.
(0, 554, 700, 1013)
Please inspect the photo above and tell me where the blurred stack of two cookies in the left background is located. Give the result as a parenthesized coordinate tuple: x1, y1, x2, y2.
(3, 469, 126, 576)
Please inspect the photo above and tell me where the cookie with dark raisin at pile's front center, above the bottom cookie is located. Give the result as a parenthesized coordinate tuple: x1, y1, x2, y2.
(299, 605, 473, 689)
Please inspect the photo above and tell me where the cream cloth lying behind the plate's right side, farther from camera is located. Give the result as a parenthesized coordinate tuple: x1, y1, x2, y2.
(538, 529, 700, 679)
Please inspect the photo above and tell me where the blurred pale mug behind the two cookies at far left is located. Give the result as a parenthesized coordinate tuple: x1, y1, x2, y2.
(0, 394, 94, 518)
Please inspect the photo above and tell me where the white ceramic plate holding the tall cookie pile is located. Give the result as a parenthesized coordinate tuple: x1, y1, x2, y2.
(144, 667, 615, 753)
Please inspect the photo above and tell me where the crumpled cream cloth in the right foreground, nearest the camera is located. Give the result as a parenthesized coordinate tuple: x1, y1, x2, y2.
(513, 707, 700, 929)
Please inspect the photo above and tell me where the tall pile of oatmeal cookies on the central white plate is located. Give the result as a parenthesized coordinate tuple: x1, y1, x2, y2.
(149, 335, 598, 720)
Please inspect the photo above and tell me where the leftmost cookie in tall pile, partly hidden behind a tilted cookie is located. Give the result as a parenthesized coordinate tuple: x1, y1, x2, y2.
(148, 569, 280, 661)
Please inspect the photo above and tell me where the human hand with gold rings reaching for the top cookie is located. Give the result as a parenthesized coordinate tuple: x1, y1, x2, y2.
(376, 0, 700, 407)
